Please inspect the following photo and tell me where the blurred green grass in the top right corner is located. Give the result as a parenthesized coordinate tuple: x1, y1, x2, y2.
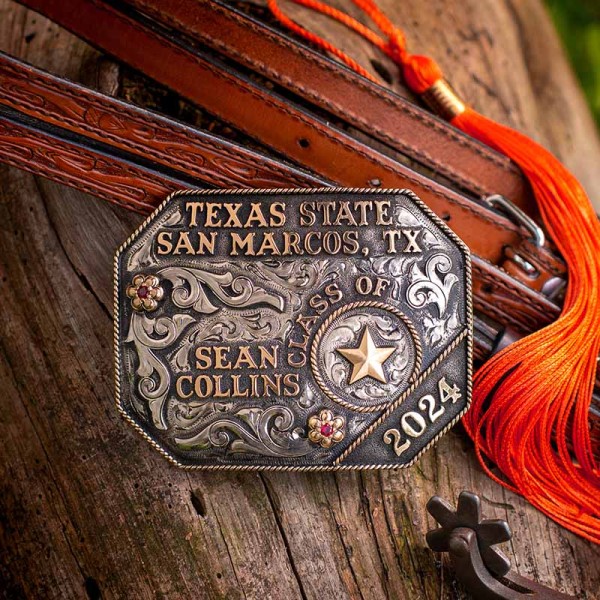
(546, 0, 600, 126)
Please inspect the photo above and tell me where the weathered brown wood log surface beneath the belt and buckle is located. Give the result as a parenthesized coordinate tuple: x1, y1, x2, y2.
(0, 0, 600, 600)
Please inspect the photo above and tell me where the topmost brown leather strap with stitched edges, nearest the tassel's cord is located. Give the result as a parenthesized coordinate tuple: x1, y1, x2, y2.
(126, 0, 537, 214)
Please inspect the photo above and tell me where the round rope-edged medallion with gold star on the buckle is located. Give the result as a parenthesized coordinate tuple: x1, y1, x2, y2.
(311, 301, 422, 412)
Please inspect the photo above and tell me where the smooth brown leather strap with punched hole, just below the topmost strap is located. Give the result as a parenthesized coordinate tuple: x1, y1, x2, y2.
(16, 0, 564, 290)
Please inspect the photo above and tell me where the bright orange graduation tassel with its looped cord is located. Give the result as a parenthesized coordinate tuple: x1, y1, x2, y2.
(268, 0, 600, 544)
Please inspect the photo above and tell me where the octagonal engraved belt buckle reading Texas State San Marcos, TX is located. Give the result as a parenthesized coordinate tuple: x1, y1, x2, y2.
(115, 188, 473, 470)
